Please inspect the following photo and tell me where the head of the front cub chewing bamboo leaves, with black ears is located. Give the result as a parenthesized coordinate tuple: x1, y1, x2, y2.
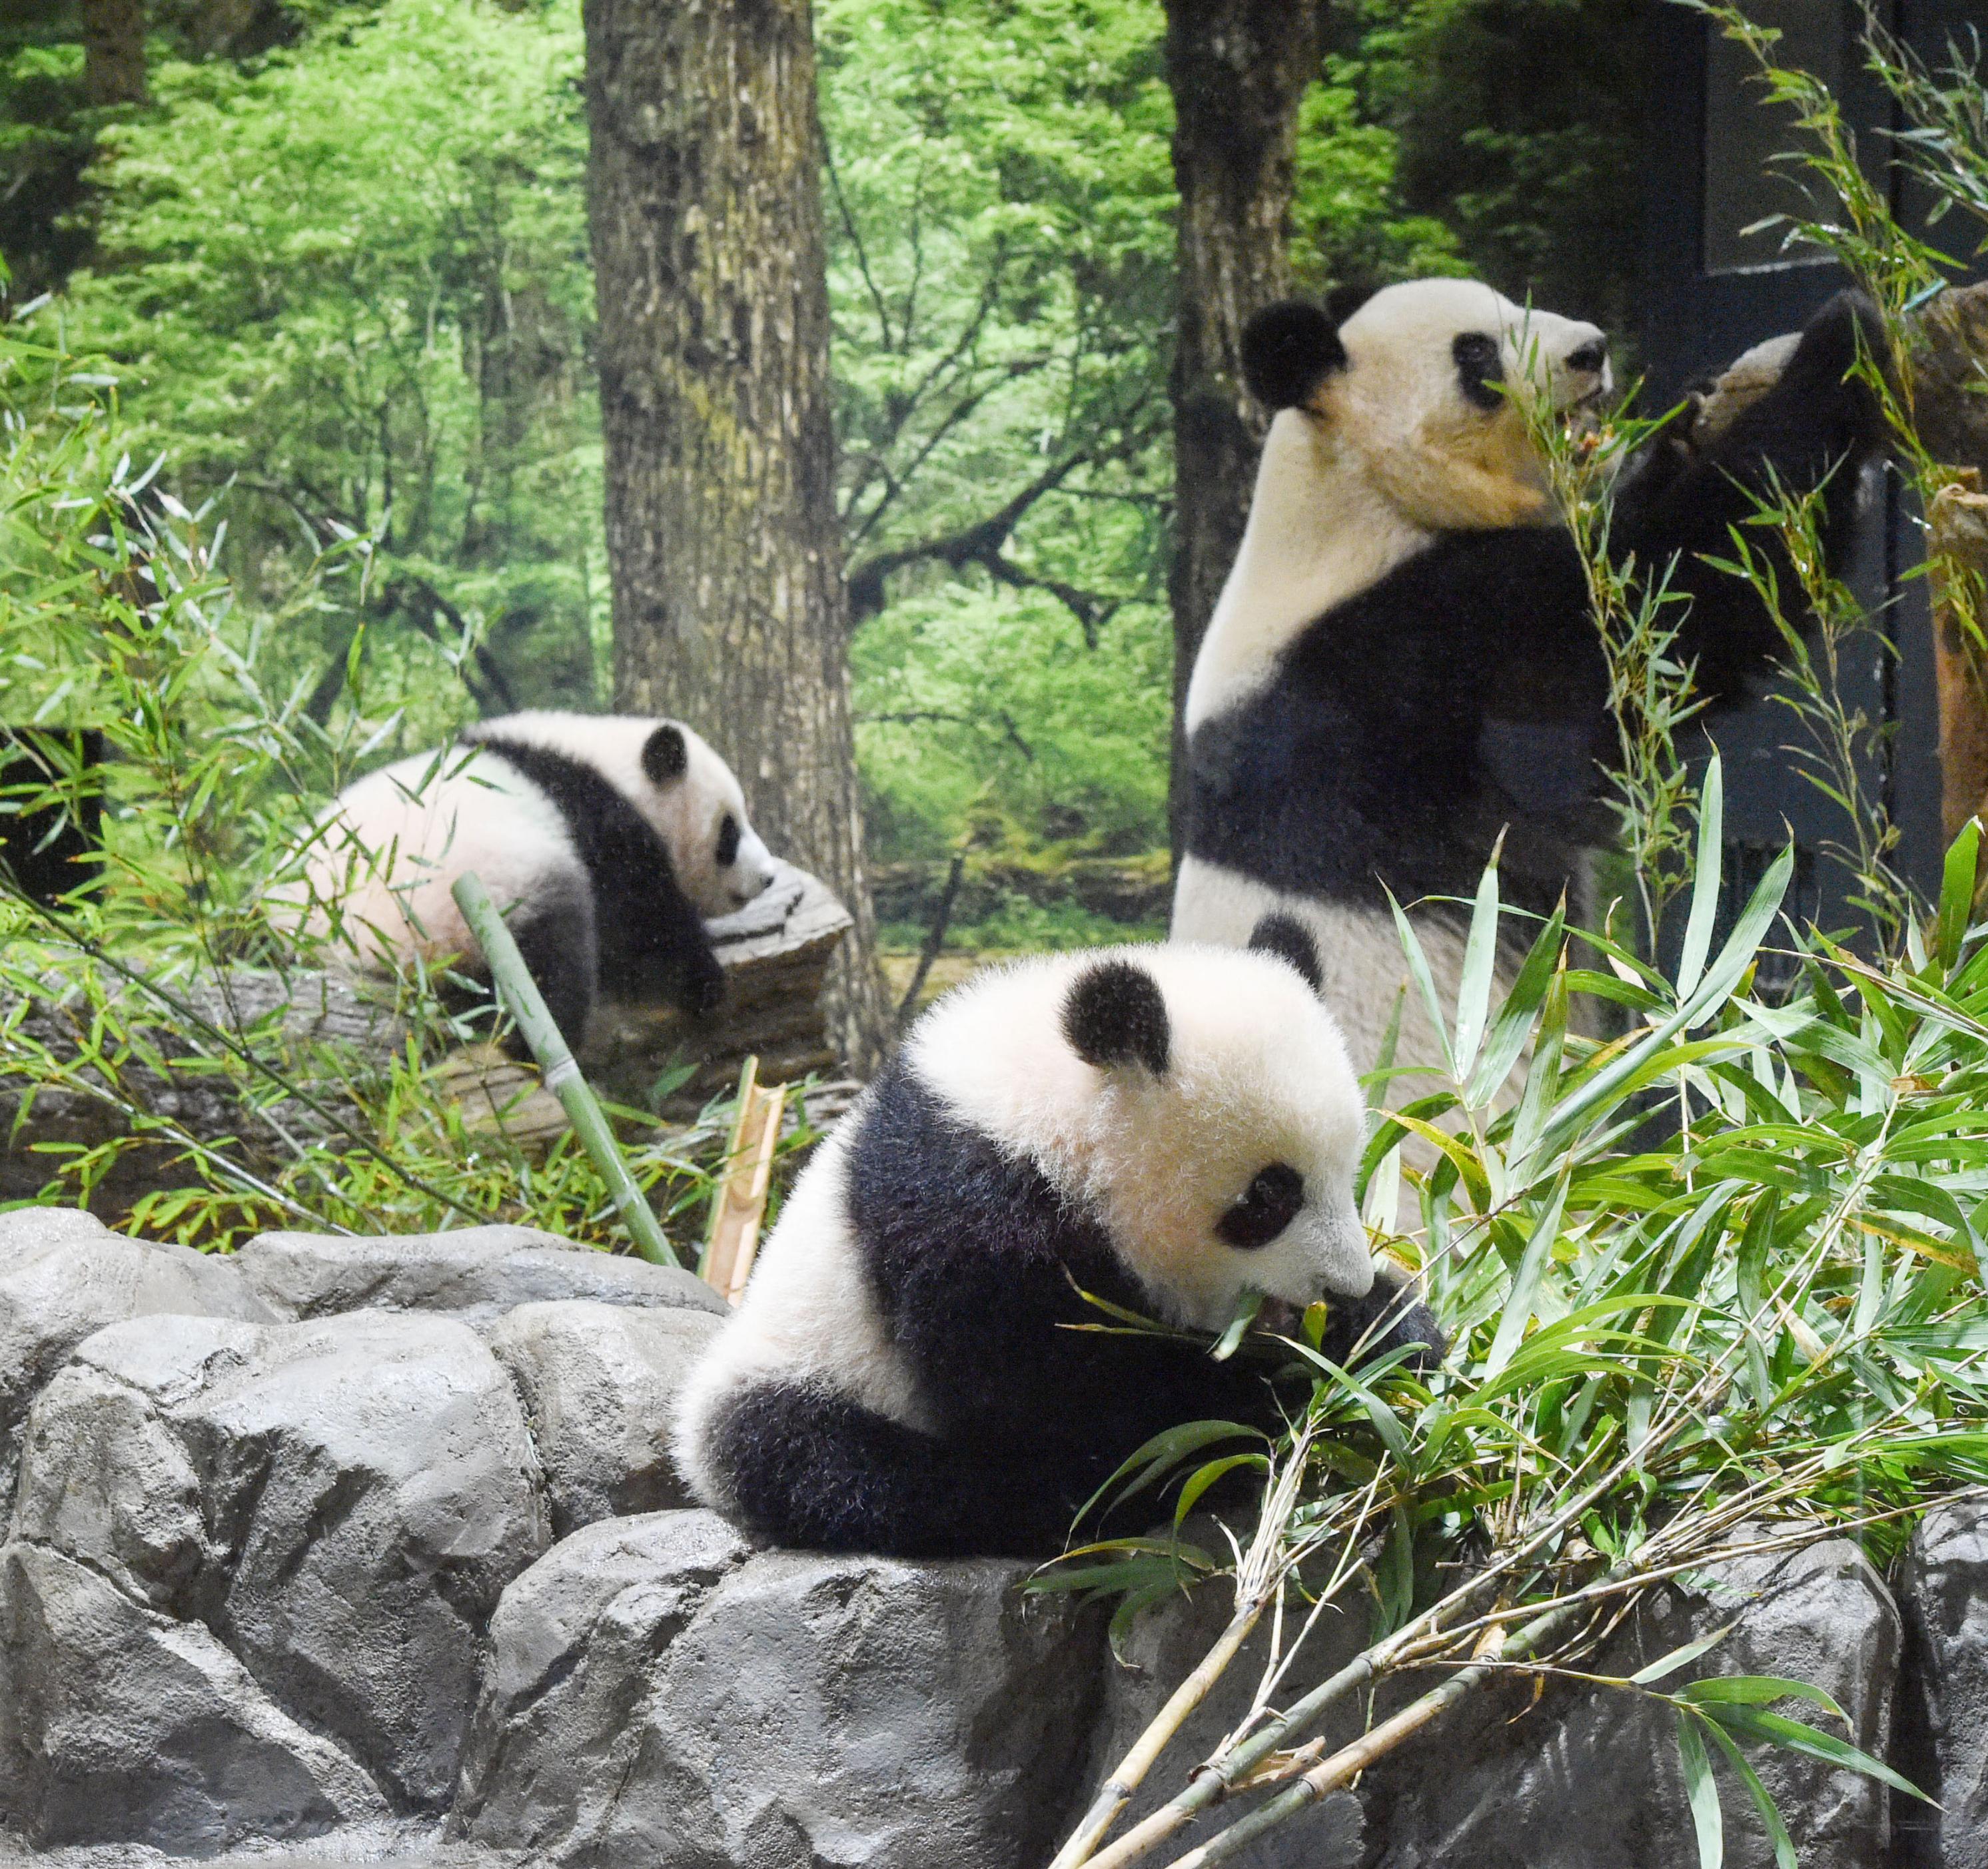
(909, 919, 1374, 1330)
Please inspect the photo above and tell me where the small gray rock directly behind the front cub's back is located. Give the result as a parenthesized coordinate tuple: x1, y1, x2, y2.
(489, 1298, 724, 1537)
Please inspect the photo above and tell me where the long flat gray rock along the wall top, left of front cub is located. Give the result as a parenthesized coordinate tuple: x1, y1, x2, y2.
(235, 1227, 726, 1328)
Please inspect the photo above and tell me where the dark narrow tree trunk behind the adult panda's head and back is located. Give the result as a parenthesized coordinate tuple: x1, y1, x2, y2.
(1167, 0, 1320, 851)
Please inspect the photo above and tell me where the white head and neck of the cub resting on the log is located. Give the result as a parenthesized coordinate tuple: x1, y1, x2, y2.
(463, 708, 773, 917)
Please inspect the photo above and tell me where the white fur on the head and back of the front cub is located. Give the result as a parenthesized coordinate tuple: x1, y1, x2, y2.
(672, 946, 1374, 1509)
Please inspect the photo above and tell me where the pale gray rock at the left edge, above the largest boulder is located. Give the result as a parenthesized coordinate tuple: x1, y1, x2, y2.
(0, 1207, 272, 1499)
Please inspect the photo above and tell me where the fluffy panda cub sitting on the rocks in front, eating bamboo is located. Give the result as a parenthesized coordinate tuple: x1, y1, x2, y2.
(674, 923, 1441, 1557)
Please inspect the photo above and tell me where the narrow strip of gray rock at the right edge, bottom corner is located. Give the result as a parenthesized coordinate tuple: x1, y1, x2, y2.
(1893, 1499, 1988, 1869)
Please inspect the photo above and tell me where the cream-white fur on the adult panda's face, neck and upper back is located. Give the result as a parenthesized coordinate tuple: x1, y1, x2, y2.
(1185, 278, 1610, 732)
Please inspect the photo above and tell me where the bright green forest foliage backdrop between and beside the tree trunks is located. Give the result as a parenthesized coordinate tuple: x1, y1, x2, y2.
(0, 0, 1636, 899)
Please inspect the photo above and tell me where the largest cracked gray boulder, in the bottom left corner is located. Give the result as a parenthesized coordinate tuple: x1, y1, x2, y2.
(0, 1312, 549, 1849)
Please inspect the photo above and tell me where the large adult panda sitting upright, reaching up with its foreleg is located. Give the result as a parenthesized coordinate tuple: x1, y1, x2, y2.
(1173, 278, 1885, 1068)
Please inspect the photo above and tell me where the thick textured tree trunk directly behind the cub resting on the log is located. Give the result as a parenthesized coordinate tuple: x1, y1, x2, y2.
(586, 0, 889, 1070)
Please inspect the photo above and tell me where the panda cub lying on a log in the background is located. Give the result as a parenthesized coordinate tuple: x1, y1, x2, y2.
(304, 710, 773, 1046)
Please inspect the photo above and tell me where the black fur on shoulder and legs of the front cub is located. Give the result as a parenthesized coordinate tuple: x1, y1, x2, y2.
(712, 1058, 1312, 1557)
